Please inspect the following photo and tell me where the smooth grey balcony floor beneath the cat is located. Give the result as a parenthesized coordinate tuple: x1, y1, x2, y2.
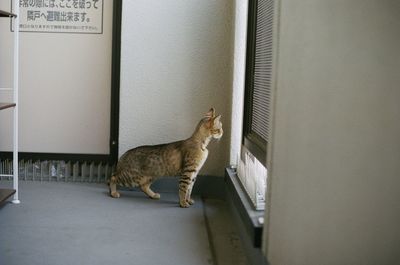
(0, 181, 246, 265)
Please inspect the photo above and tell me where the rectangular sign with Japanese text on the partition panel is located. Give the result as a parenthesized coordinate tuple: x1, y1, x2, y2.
(15, 0, 103, 34)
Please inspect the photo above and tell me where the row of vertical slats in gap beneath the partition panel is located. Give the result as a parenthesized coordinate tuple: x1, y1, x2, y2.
(0, 160, 114, 183)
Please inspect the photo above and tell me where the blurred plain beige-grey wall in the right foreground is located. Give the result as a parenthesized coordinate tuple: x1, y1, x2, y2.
(264, 0, 400, 265)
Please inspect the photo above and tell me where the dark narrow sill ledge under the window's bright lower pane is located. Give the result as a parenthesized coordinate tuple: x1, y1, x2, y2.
(225, 168, 264, 248)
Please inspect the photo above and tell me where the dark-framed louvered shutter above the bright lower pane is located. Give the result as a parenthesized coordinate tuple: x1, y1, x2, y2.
(244, 0, 274, 165)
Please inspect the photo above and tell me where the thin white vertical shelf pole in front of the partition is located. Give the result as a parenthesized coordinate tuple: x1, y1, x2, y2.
(12, 0, 20, 204)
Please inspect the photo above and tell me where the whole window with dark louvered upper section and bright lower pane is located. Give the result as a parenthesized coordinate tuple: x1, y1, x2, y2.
(238, 0, 274, 209)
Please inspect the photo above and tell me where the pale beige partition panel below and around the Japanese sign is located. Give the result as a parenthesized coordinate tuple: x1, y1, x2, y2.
(0, 0, 113, 154)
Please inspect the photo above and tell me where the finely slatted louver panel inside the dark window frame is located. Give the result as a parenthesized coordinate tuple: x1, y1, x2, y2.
(251, 0, 274, 142)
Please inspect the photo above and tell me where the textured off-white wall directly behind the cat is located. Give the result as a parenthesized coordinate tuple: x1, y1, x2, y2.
(119, 0, 233, 175)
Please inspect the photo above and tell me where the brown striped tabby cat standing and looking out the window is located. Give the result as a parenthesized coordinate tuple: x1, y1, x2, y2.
(109, 108, 223, 208)
